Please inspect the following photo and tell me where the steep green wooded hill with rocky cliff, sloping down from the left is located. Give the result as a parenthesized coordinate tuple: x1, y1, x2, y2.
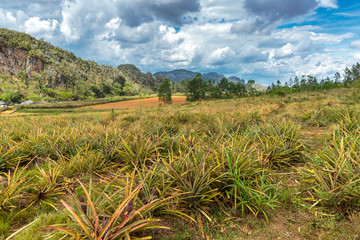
(0, 28, 155, 101)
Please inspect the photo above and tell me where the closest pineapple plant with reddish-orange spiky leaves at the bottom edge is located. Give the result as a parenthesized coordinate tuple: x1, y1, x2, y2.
(45, 175, 169, 240)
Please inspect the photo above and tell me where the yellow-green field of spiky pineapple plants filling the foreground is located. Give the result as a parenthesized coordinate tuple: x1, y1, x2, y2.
(0, 89, 360, 240)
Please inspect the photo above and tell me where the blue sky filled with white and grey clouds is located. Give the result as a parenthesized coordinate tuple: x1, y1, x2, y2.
(0, 0, 360, 85)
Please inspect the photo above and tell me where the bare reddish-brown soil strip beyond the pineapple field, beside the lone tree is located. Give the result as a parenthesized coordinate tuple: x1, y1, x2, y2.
(82, 96, 186, 109)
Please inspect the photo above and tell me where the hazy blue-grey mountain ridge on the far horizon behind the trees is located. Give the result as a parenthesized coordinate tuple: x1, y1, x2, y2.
(154, 69, 245, 83)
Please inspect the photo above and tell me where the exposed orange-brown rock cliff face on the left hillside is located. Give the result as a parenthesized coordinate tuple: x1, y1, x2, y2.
(0, 42, 44, 77)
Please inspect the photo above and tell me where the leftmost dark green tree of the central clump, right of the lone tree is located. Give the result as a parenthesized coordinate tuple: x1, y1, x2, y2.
(186, 73, 207, 102)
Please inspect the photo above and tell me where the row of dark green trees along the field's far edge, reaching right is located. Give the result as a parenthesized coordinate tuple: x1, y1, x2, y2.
(158, 63, 360, 103)
